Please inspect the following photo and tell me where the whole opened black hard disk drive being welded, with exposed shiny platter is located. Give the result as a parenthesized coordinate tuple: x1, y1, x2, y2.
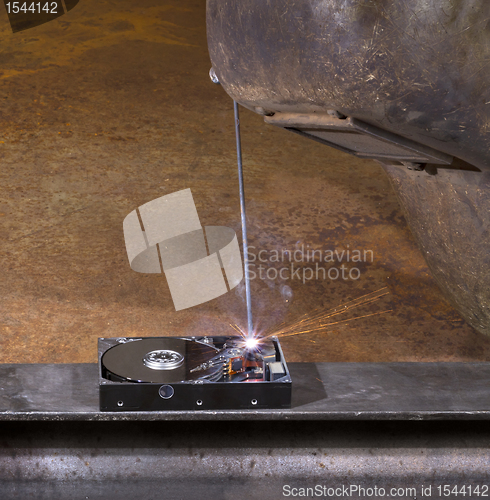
(99, 336, 291, 411)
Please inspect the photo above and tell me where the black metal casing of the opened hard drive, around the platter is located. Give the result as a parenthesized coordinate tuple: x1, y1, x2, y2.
(98, 336, 291, 412)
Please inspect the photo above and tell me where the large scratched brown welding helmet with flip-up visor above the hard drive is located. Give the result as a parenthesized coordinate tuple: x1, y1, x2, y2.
(207, 0, 490, 335)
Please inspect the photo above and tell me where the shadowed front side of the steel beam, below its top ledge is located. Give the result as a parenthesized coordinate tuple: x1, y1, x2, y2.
(0, 422, 490, 500)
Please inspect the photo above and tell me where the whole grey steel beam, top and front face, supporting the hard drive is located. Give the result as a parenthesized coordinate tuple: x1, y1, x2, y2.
(0, 363, 490, 500)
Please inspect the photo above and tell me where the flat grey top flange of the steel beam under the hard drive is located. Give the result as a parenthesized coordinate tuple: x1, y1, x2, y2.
(0, 363, 490, 421)
